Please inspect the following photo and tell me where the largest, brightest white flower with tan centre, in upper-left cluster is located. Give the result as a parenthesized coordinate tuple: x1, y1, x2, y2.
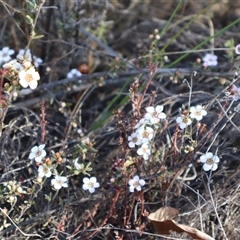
(18, 67, 40, 89)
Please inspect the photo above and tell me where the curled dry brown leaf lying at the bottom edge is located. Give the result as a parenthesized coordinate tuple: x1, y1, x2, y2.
(148, 207, 214, 240)
